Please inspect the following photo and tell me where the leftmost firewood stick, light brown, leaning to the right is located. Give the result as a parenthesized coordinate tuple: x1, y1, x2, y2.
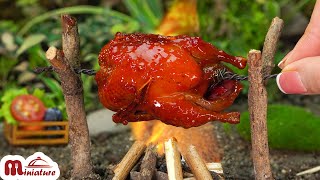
(113, 141, 146, 180)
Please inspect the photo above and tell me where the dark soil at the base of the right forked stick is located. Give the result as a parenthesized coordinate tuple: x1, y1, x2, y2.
(216, 124, 320, 180)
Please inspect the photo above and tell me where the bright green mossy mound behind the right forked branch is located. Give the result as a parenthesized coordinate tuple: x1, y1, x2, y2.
(237, 105, 320, 151)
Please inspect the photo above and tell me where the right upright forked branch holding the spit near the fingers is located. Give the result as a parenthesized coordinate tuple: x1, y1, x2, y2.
(248, 17, 283, 180)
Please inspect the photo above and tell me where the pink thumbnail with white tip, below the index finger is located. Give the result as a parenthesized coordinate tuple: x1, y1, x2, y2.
(277, 71, 307, 94)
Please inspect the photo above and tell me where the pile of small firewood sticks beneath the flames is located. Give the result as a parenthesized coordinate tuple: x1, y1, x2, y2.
(113, 138, 223, 180)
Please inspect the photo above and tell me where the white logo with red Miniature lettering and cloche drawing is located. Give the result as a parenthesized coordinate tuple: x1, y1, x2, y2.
(0, 152, 60, 180)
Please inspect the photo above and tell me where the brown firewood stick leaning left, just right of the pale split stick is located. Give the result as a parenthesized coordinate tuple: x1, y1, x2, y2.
(184, 145, 212, 180)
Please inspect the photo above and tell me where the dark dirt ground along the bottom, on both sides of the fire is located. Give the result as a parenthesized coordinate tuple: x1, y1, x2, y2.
(0, 123, 320, 180)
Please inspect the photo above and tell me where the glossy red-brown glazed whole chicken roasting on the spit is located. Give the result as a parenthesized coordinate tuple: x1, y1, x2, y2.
(96, 33, 246, 128)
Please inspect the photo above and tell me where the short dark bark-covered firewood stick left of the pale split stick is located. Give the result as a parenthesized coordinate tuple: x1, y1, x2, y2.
(140, 145, 157, 180)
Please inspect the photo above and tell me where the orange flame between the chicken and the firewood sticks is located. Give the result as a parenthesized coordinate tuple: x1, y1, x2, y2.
(131, 120, 221, 162)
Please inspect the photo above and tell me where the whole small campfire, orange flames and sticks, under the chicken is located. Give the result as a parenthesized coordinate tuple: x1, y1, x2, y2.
(113, 120, 223, 180)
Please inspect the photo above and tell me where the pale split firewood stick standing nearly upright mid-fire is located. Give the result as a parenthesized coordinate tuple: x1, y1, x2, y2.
(164, 138, 183, 180)
